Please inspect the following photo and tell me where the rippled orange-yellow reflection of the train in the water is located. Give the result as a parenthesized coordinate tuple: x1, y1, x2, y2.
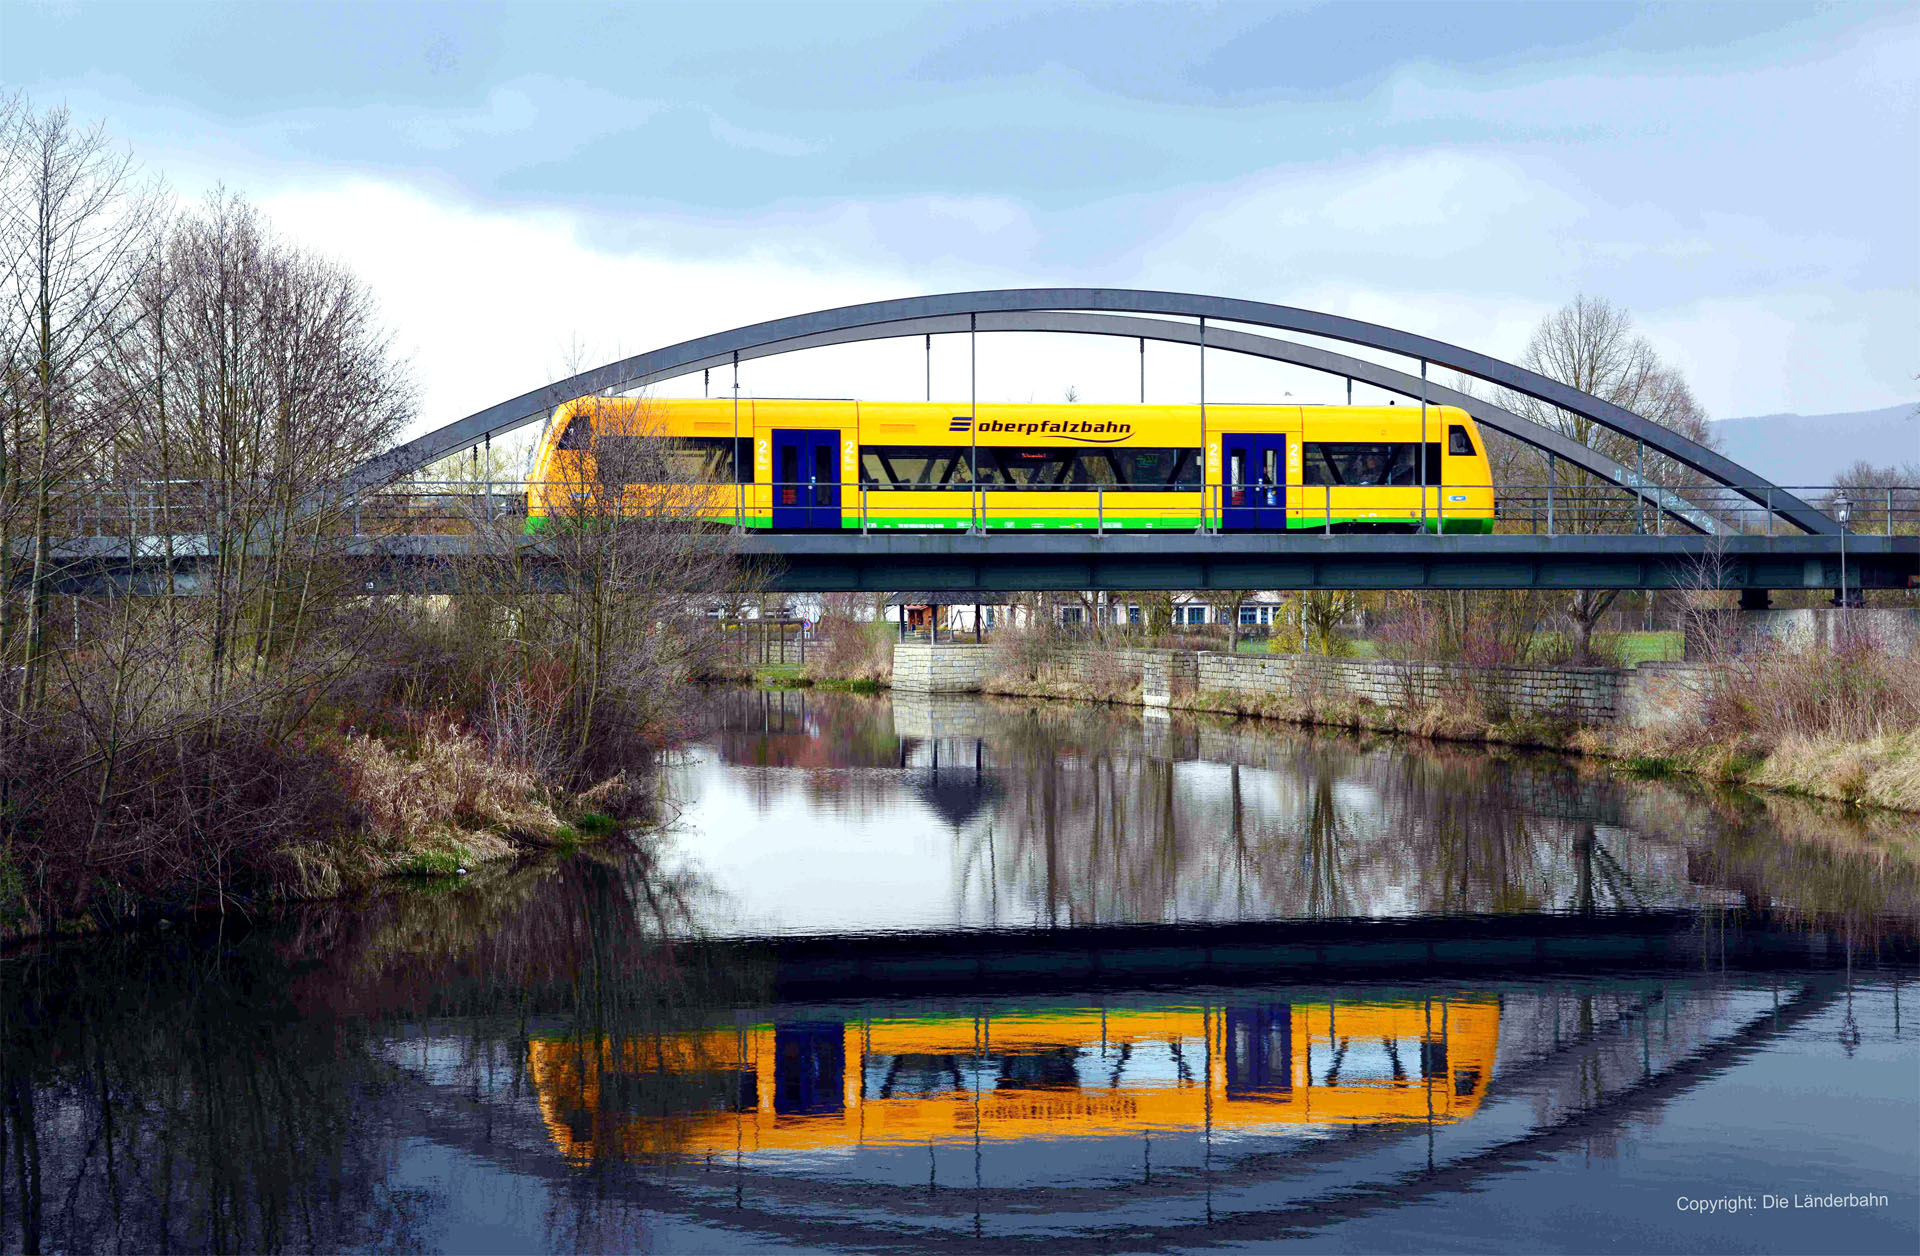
(530, 997, 1500, 1160)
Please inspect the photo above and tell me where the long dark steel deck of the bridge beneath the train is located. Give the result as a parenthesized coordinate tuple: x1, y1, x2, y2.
(45, 532, 1920, 593)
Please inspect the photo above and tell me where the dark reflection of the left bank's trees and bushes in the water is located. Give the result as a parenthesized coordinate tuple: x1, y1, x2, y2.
(0, 851, 766, 1252)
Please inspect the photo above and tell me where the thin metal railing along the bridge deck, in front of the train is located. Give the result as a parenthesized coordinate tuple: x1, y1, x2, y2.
(37, 480, 1920, 538)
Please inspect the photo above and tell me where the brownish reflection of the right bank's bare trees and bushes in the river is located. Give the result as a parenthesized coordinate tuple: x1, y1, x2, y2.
(672, 693, 1920, 924)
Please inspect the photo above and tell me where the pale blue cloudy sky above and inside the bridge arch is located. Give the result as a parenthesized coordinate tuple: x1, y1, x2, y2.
(15, 6, 1920, 423)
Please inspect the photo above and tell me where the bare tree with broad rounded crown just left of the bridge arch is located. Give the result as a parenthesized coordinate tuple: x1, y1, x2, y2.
(119, 192, 413, 699)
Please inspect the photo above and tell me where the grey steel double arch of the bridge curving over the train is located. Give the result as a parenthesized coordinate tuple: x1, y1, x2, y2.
(348, 288, 1839, 534)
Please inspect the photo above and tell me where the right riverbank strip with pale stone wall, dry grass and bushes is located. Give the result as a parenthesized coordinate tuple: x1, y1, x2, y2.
(798, 632, 1920, 810)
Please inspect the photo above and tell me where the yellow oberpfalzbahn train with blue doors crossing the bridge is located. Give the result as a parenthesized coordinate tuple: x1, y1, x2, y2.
(528, 398, 1494, 534)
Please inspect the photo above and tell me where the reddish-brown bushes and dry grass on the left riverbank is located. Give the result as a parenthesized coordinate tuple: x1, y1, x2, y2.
(0, 605, 685, 939)
